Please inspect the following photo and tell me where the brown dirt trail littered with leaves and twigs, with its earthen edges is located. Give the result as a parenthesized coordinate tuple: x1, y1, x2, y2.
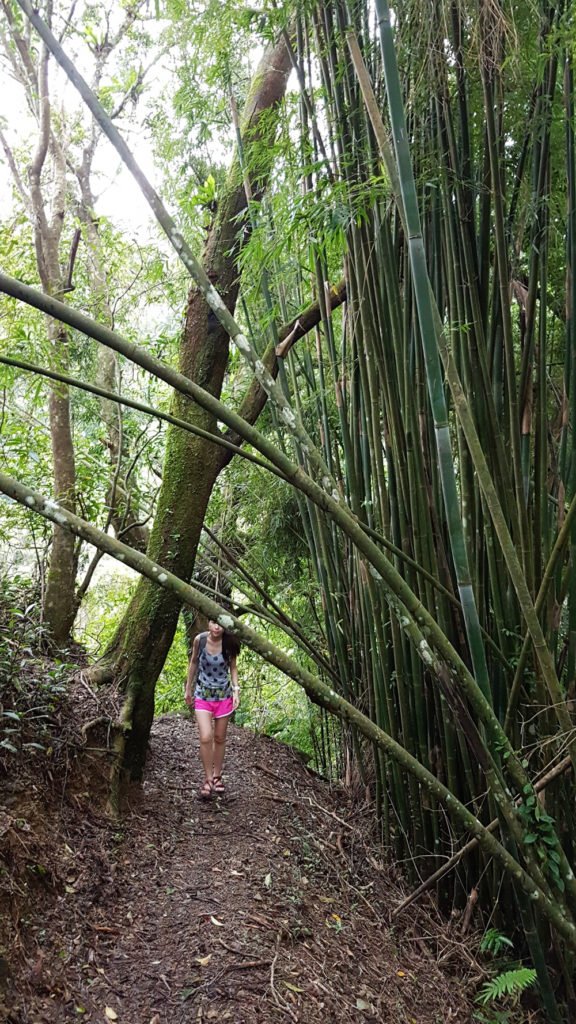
(0, 716, 470, 1024)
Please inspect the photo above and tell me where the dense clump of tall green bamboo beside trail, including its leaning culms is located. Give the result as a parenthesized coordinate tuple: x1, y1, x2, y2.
(0, 0, 576, 1022)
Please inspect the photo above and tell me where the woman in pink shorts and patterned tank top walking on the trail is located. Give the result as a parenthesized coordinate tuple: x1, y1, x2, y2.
(184, 621, 240, 800)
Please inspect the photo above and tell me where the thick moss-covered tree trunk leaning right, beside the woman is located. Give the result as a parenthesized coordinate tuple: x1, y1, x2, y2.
(101, 40, 291, 779)
